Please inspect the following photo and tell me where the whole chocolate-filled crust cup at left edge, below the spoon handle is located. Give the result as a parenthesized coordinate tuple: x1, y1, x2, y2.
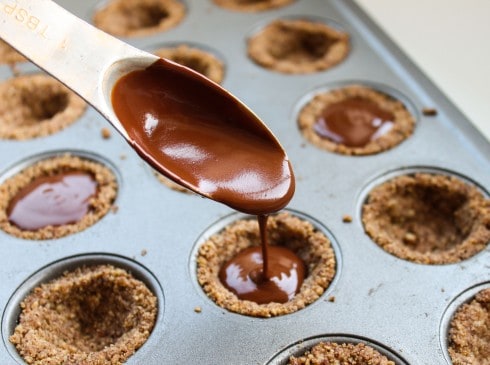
(0, 153, 118, 240)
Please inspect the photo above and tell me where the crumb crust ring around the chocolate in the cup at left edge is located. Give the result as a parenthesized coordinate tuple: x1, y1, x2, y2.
(0, 154, 117, 240)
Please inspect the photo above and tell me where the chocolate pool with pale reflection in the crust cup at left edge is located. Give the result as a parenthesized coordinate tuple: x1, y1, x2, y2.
(7, 172, 97, 230)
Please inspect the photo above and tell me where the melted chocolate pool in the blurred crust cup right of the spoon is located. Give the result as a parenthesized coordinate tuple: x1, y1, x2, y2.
(313, 97, 394, 147)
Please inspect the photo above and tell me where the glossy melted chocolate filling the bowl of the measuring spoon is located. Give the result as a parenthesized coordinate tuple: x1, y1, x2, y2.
(112, 59, 294, 214)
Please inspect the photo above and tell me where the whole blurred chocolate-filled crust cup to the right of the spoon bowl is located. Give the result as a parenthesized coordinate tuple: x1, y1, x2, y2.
(297, 84, 415, 155)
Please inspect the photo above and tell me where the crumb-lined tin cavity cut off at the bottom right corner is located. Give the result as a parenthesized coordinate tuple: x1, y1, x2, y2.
(441, 282, 490, 365)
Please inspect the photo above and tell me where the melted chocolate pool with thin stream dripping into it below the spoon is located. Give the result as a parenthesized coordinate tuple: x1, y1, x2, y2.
(219, 216, 306, 304)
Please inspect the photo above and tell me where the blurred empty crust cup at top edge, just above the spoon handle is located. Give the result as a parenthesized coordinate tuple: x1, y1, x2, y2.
(93, 0, 186, 37)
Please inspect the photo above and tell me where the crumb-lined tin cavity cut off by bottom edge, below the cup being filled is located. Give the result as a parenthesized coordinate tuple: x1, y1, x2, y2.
(267, 335, 407, 365)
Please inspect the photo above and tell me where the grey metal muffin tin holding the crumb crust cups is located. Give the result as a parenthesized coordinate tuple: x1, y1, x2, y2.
(0, 0, 490, 365)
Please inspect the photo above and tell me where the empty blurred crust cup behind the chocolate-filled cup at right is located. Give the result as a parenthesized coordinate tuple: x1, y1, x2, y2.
(248, 20, 350, 74)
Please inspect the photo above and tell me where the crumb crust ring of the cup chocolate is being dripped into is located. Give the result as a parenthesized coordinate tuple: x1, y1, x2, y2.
(197, 213, 336, 317)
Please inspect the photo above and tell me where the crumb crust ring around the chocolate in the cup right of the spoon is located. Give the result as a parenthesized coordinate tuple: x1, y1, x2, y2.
(298, 85, 415, 155)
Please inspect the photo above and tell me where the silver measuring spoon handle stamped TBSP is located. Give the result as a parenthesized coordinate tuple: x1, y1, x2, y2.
(0, 0, 156, 134)
